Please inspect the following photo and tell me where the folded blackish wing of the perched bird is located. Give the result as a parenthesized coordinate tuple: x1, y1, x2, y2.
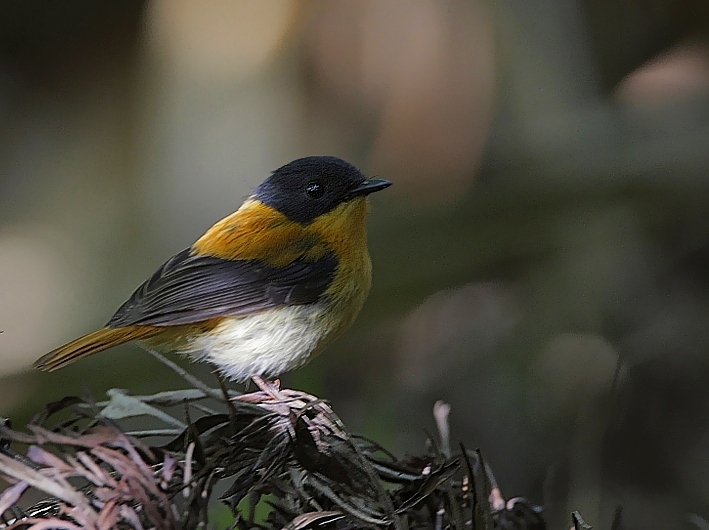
(107, 249, 337, 328)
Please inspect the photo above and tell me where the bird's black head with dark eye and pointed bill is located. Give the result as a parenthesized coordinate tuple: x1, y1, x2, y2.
(254, 156, 391, 224)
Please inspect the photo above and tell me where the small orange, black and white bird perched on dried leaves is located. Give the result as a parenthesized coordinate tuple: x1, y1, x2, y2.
(34, 156, 391, 382)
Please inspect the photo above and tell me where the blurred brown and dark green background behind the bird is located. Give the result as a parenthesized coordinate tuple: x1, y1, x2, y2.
(0, 0, 709, 529)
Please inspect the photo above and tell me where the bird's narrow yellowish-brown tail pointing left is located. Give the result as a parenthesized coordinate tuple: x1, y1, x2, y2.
(34, 326, 160, 371)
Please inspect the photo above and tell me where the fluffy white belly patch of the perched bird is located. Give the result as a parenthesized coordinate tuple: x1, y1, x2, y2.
(182, 306, 334, 381)
